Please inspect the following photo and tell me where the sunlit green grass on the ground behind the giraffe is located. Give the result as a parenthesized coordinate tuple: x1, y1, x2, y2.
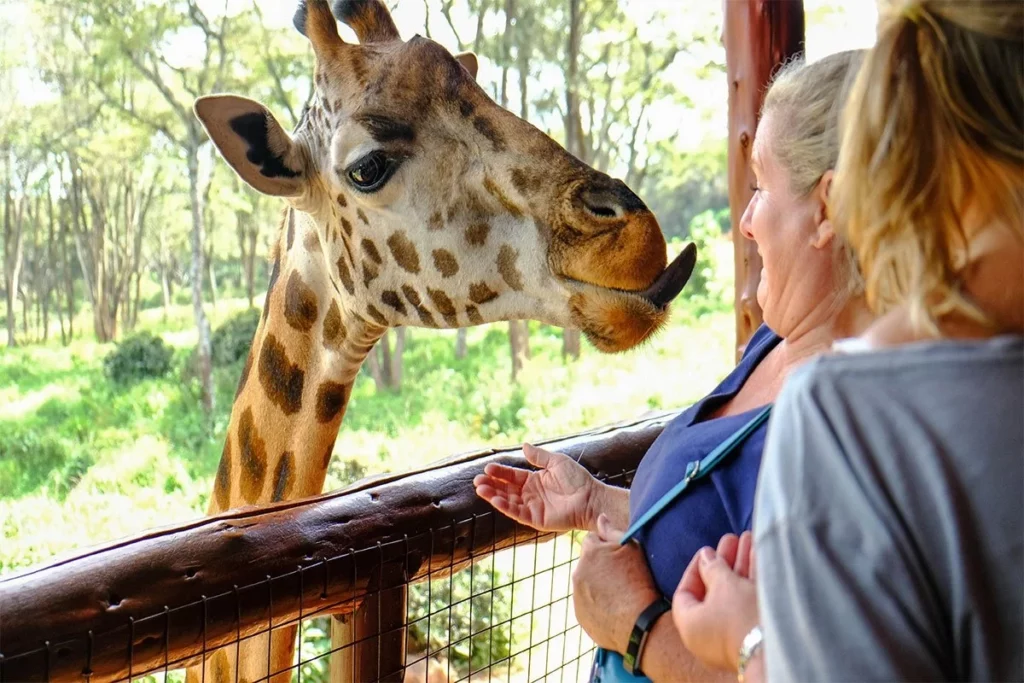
(0, 237, 734, 573)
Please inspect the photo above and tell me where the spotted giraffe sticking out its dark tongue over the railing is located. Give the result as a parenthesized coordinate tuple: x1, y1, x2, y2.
(188, 0, 695, 681)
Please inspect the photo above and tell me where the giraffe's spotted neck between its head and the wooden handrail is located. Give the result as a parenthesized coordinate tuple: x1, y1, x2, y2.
(210, 209, 386, 513)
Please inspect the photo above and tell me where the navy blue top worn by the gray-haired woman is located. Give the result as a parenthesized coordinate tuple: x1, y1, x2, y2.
(630, 325, 781, 597)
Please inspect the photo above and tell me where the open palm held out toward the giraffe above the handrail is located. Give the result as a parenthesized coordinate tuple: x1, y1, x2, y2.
(473, 443, 599, 531)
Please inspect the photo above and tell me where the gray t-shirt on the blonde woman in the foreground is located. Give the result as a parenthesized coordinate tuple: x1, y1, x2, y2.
(754, 337, 1024, 683)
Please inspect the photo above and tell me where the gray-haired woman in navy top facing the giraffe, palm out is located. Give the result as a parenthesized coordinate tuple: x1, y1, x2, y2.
(475, 51, 866, 680)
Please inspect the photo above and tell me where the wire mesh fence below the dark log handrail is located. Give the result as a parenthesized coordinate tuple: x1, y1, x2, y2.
(0, 472, 632, 683)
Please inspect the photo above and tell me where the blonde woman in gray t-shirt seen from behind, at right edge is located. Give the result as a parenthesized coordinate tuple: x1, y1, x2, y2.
(673, 0, 1024, 681)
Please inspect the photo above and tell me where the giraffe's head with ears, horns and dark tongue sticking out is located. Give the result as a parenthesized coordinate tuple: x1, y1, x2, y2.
(196, 0, 695, 351)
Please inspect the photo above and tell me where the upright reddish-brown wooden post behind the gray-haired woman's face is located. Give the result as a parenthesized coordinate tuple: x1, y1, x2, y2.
(723, 0, 804, 359)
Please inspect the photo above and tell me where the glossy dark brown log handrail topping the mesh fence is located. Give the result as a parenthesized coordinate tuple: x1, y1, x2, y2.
(0, 412, 676, 682)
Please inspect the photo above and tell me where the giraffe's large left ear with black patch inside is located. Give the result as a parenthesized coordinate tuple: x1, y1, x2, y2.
(194, 95, 305, 197)
